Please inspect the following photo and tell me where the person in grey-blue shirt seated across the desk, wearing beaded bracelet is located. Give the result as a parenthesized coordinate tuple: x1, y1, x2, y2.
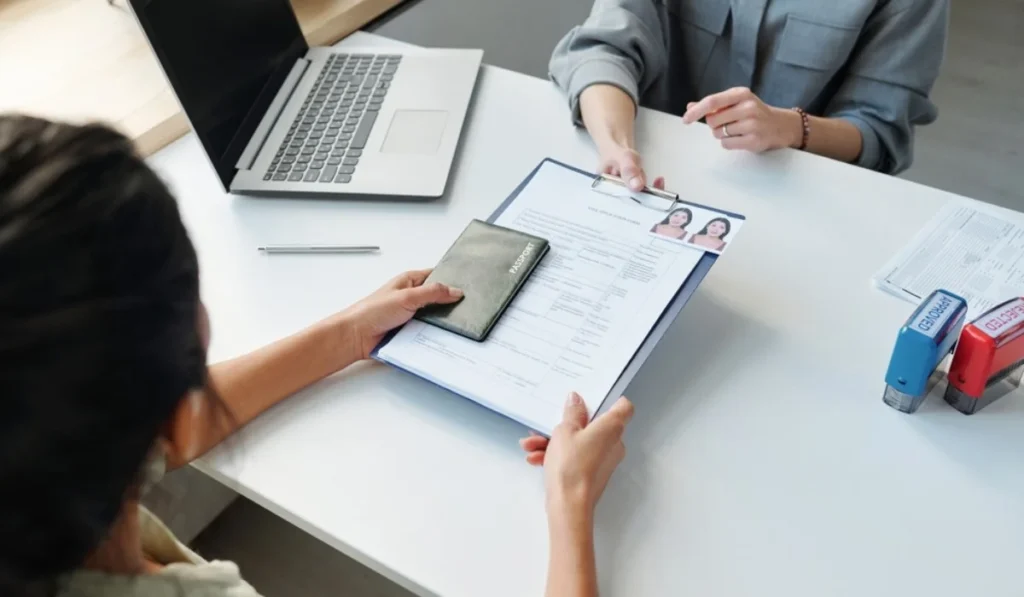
(550, 0, 949, 188)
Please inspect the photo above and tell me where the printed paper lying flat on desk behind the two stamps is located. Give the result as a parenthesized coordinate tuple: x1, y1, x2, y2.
(872, 201, 1024, 319)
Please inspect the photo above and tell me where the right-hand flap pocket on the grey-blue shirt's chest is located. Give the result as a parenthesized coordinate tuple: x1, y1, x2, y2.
(775, 14, 860, 73)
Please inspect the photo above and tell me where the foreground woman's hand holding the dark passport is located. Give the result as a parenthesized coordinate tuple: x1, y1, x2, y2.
(340, 269, 463, 358)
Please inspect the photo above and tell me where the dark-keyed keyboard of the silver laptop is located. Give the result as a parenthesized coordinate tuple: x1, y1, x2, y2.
(263, 54, 401, 183)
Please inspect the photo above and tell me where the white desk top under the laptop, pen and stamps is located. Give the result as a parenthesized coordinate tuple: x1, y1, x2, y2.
(152, 35, 1024, 597)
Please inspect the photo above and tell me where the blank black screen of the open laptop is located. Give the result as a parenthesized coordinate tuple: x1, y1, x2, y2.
(131, 0, 307, 188)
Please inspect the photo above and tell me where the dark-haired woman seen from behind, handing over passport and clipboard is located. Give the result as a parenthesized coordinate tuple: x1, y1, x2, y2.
(0, 117, 632, 597)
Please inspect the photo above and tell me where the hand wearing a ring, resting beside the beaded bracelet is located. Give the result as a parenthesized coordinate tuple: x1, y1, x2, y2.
(683, 87, 804, 154)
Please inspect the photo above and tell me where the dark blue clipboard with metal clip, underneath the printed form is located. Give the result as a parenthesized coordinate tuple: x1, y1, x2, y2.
(371, 158, 746, 427)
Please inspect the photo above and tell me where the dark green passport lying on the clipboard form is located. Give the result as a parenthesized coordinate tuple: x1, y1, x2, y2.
(416, 220, 549, 342)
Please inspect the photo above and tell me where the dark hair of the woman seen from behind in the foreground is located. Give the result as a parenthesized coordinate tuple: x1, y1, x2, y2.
(0, 117, 206, 596)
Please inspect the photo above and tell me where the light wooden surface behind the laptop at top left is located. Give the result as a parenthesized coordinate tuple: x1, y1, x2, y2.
(0, 0, 400, 155)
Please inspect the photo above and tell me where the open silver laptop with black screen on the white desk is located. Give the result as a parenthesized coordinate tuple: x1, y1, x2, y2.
(130, 0, 483, 199)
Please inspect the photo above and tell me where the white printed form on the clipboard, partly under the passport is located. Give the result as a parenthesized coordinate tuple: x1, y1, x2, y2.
(377, 162, 742, 433)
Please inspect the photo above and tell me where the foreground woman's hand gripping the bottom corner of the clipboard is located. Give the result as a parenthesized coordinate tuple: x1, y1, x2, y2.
(519, 392, 633, 520)
